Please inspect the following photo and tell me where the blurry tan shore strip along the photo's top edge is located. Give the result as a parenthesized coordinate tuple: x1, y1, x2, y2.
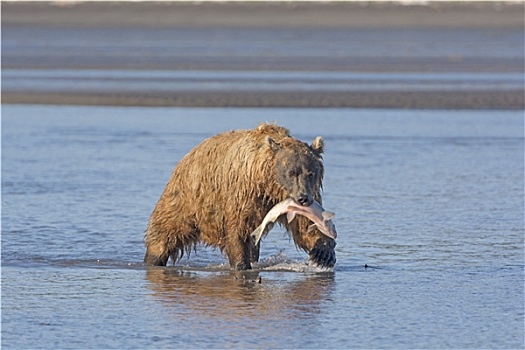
(1, 1, 524, 28)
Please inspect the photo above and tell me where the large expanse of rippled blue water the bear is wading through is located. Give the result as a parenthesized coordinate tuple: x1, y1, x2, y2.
(2, 105, 524, 349)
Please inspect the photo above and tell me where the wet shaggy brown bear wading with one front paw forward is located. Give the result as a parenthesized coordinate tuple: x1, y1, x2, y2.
(144, 124, 336, 270)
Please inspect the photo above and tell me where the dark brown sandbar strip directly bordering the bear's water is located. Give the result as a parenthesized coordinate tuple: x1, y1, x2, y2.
(2, 91, 525, 110)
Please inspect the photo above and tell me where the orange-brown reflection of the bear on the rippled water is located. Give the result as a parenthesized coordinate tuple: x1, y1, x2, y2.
(146, 268, 335, 319)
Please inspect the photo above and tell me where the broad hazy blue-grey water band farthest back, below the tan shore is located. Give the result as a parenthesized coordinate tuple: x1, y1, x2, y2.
(2, 26, 524, 71)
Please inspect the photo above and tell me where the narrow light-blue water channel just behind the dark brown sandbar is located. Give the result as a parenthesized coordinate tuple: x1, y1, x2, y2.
(2, 69, 523, 94)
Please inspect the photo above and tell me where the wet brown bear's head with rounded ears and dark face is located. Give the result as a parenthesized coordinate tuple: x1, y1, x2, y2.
(266, 136, 324, 206)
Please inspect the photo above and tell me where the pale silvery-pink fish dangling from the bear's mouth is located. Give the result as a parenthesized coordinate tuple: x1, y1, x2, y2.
(250, 198, 337, 244)
